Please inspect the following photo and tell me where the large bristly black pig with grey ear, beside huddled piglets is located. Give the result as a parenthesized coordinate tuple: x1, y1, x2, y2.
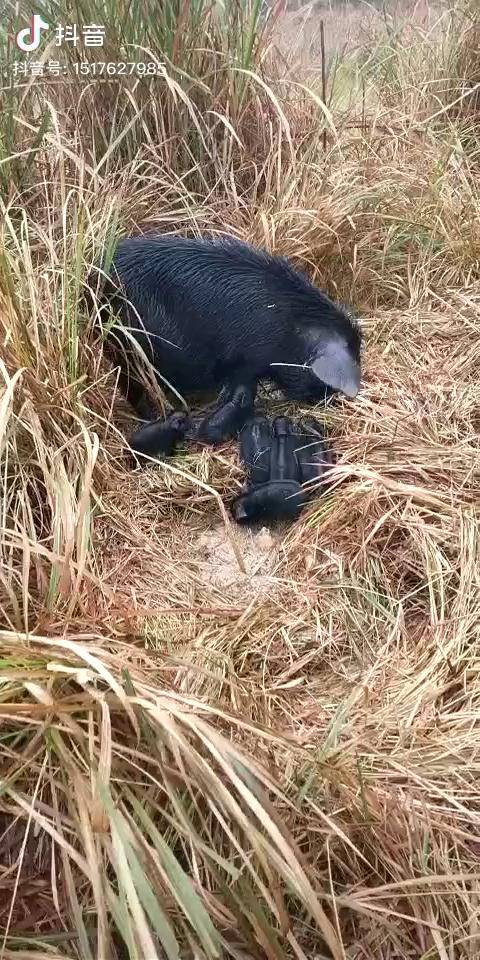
(95, 234, 361, 455)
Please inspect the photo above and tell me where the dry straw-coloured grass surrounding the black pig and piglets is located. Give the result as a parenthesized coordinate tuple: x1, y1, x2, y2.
(0, 5, 480, 960)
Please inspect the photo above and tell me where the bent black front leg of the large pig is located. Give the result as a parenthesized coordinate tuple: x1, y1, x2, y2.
(188, 381, 256, 444)
